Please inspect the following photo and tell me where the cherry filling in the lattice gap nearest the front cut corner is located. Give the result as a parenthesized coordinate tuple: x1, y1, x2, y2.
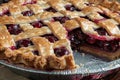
(54, 47, 70, 57)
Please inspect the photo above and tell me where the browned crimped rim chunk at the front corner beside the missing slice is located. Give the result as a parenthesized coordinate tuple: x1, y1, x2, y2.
(48, 55, 76, 69)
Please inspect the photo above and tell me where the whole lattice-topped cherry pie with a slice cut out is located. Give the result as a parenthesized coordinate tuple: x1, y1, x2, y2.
(0, 0, 120, 70)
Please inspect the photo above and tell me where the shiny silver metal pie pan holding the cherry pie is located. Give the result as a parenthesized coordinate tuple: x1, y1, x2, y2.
(0, 1, 120, 80)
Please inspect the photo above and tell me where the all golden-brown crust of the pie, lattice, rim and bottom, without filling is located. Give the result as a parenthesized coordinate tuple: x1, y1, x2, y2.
(0, 0, 120, 69)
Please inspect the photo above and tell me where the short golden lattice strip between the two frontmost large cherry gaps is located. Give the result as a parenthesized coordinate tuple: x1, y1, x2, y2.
(32, 37, 54, 56)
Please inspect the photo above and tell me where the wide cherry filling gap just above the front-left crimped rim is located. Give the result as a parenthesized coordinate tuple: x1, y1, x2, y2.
(16, 39, 33, 49)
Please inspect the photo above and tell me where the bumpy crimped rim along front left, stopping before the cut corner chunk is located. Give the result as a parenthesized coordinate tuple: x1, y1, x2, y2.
(5, 48, 47, 69)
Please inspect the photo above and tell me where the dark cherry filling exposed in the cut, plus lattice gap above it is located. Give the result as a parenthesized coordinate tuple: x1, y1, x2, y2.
(68, 28, 120, 52)
